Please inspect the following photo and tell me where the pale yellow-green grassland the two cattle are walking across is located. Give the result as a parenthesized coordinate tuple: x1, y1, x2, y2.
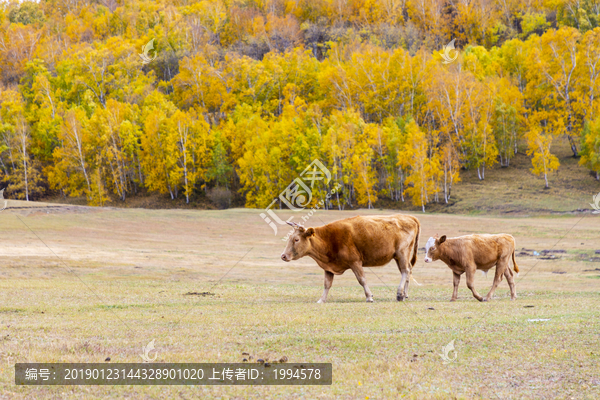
(0, 205, 600, 399)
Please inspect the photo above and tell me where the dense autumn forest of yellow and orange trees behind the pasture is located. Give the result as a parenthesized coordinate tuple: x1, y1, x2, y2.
(0, 0, 600, 211)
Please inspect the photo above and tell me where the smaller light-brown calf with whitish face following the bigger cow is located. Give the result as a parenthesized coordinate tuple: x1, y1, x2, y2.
(425, 233, 519, 301)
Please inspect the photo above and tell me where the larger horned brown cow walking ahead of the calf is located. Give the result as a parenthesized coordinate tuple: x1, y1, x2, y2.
(281, 214, 421, 303)
